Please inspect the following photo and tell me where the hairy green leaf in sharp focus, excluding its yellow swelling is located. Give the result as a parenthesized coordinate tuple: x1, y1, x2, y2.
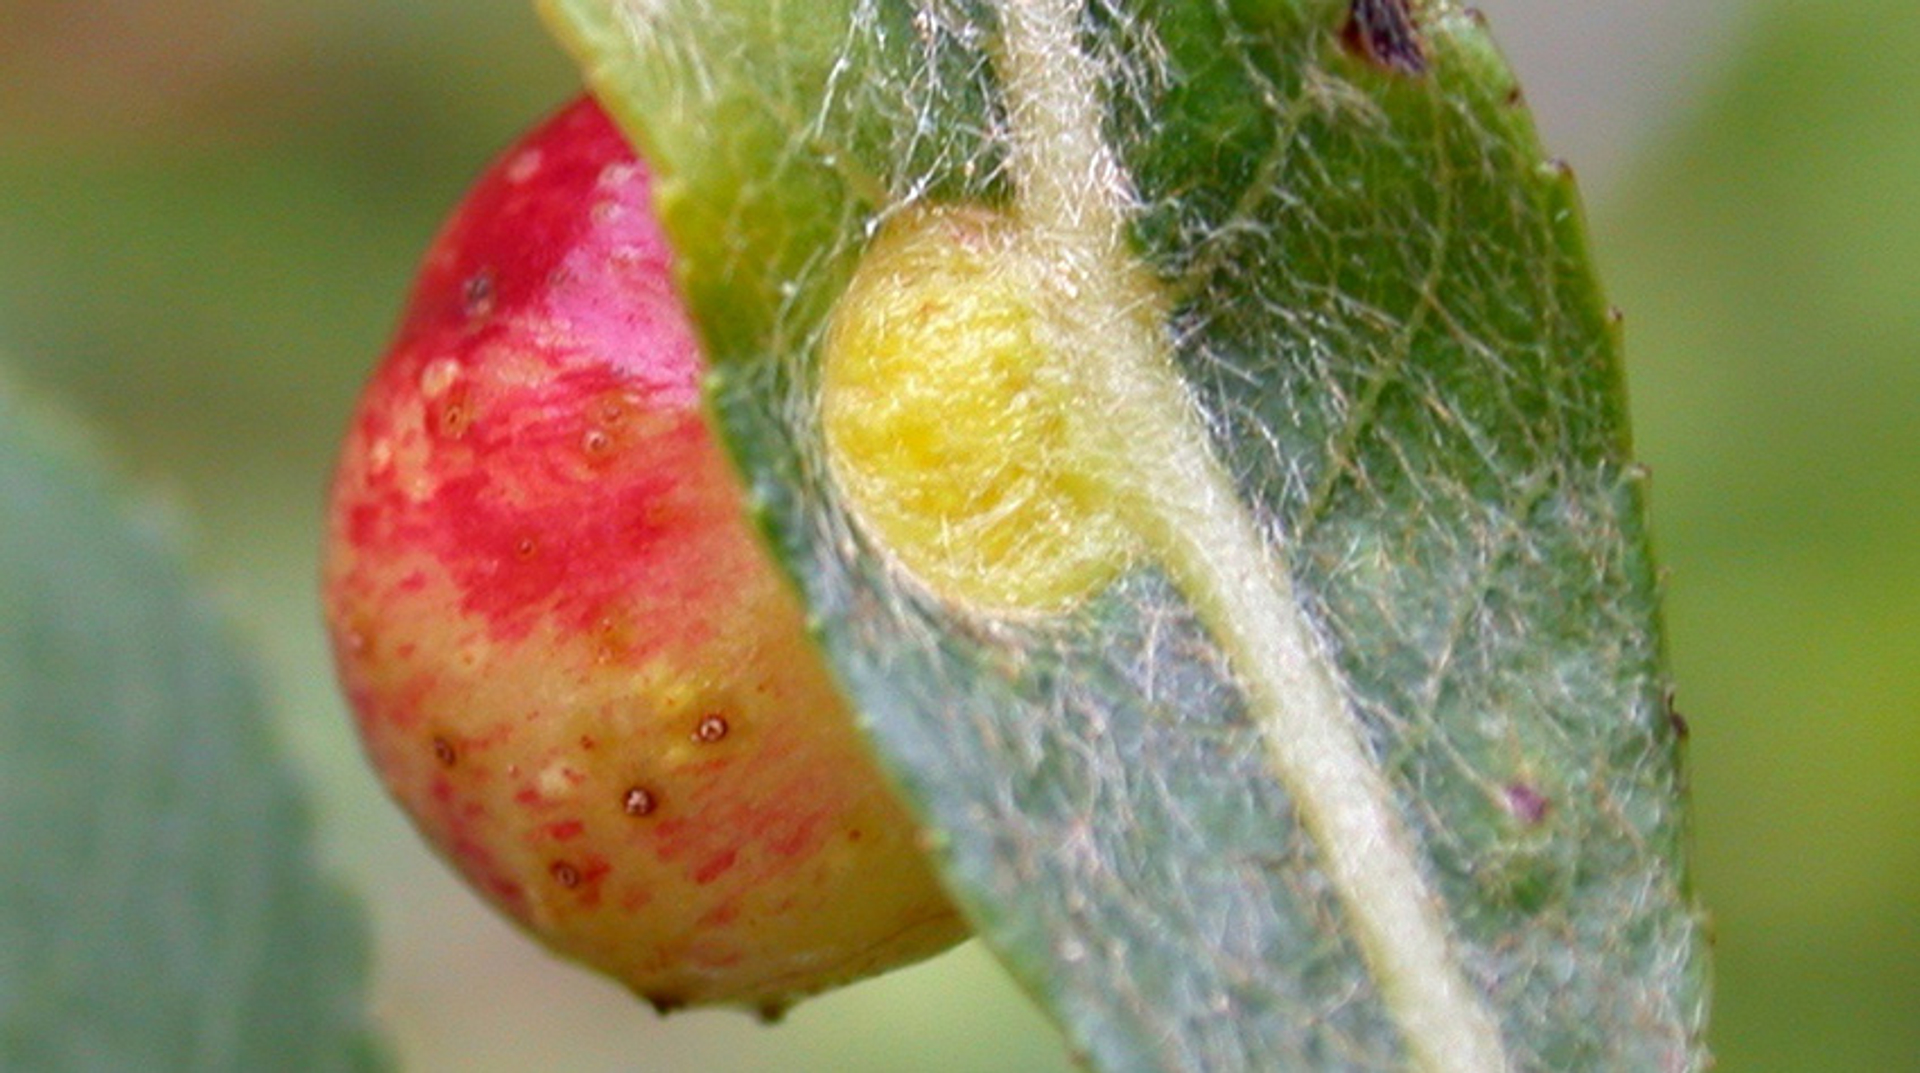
(547, 0, 1705, 1069)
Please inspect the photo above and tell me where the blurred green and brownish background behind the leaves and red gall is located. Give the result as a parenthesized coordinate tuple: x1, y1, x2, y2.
(0, 0, 1920, 1073)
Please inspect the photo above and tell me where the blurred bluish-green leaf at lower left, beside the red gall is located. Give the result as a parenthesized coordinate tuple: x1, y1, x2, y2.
(0, 393, 378, 1071)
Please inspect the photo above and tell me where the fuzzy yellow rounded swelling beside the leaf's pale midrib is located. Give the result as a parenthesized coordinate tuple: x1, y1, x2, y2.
(822, 207, 1133, 614)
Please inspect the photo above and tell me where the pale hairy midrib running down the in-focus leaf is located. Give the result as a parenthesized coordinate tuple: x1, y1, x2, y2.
(996, 0, 1509, 1073)
